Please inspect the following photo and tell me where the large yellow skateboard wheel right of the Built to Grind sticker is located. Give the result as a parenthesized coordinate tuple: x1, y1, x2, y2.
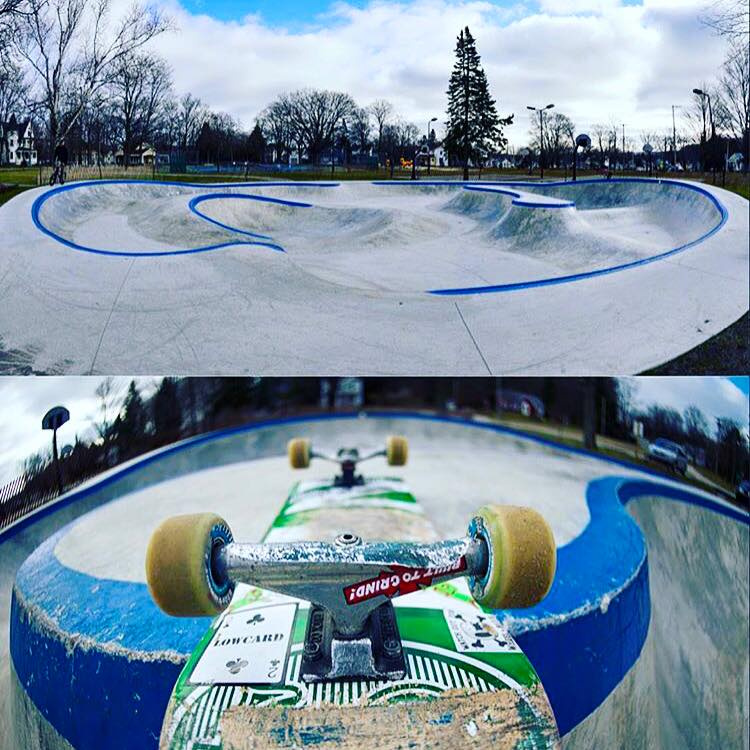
(469, 505, 557, 609)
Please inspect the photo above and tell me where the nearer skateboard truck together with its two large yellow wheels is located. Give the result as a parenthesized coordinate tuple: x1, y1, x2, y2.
(146, 505, 556, 682)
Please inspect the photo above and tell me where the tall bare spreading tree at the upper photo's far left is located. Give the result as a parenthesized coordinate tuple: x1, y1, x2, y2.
(14, 0, 169, 146)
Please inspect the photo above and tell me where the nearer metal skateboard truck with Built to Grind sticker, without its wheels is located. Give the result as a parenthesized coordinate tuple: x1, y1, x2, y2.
(210, 534, 488, 682)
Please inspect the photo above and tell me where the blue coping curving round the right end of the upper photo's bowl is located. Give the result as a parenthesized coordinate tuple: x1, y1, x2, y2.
(428, 177, 729, 296)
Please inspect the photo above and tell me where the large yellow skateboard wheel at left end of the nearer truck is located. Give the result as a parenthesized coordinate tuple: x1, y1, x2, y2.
(146, 513, 234, 617)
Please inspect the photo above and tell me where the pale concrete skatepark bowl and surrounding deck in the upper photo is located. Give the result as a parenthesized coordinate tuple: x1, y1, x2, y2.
(0, 178, 750, 375)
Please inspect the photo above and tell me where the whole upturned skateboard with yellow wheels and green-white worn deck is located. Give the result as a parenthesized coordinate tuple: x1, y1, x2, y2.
(146, 436, 559, 750)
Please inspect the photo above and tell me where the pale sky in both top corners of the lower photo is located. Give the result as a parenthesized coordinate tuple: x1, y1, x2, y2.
(0, 376, 750, 486)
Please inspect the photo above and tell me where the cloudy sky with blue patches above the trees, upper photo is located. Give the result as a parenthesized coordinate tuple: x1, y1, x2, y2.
(132, 0, 725, 146)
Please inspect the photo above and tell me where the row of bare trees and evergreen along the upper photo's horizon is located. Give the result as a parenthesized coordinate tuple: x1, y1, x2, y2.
(0, 0, 750, 172)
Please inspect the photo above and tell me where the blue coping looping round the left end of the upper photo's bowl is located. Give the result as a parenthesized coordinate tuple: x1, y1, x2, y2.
(31, 179, 340, 258)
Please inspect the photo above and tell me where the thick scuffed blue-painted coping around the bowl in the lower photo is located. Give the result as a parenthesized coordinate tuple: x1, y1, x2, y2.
(8, 411, 750, 750)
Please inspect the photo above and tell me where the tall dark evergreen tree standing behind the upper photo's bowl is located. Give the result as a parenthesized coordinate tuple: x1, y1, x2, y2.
(445, 26, 513, 180)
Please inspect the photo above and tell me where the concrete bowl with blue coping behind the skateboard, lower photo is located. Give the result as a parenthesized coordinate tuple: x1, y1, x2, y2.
(0, 413, 750, 750)
